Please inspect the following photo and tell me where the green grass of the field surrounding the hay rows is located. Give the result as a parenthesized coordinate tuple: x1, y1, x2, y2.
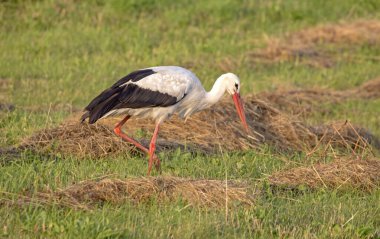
(0, 0, 380, 238)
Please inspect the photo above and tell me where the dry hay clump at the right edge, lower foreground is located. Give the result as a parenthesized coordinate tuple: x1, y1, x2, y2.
(269, 159, 380, 191)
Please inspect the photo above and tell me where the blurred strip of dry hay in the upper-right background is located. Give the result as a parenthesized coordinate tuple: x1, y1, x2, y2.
(250, 20, 380, 67)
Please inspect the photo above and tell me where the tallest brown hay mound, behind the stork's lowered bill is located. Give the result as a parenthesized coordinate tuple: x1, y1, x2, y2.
(96, 96, 317, 152)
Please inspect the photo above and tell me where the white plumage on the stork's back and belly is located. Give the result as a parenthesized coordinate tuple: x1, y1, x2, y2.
(99, 66, 206, 123)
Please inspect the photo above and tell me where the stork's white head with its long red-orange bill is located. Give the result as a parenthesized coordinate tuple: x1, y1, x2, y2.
(222, 73, 248, 132)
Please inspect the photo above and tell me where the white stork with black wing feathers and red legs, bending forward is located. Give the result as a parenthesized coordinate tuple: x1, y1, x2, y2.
(81, 66, 248, 175)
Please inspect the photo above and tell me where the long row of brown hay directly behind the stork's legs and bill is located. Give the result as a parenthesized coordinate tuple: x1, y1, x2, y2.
(14, 91, 380, 158)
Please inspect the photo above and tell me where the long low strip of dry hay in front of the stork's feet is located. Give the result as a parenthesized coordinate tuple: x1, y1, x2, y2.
(48, 176, 255, 208)
